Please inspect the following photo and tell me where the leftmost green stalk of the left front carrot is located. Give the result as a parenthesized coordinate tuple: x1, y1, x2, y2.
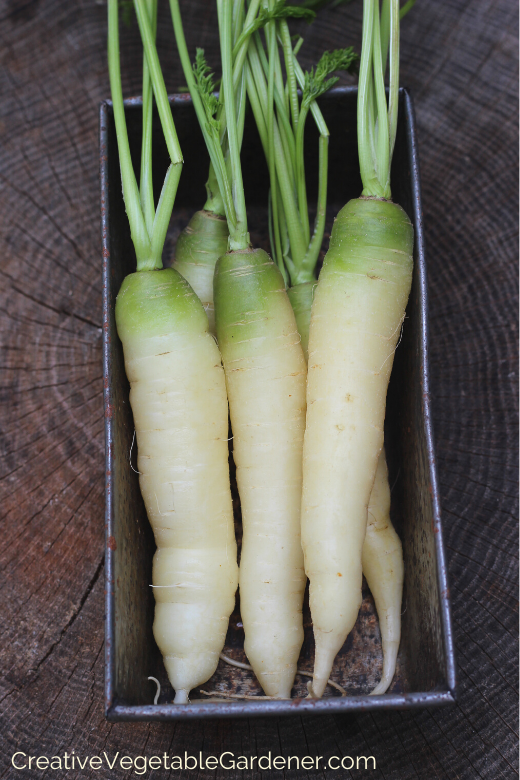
(108, 0, 150, 271)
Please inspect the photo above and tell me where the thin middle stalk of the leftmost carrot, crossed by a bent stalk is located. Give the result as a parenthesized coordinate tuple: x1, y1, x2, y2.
(139, 0, 157, 236)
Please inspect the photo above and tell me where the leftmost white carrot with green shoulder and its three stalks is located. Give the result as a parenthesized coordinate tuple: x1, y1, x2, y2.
(108, 0, 238, 703)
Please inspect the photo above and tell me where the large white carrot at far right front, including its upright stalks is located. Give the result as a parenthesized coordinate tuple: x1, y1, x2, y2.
(302, 0, 413, 697)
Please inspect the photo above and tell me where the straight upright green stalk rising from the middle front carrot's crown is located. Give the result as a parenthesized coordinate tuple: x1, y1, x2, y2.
(217, 0, 250, 251)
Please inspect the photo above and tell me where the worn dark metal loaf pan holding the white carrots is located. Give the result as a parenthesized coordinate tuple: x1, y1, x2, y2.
(100, 88, 455, 721)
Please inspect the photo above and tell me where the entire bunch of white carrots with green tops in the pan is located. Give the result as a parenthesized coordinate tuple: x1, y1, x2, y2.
(108, 0, 413, 704)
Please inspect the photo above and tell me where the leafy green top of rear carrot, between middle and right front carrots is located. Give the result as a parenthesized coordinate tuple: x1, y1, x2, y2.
(242, 18, 358, 354)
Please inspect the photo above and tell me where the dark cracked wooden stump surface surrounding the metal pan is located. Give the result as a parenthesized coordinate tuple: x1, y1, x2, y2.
(0, 0, 518, 780)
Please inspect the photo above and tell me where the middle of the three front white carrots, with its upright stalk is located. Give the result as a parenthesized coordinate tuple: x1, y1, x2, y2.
(209, 0, 305, 698)
